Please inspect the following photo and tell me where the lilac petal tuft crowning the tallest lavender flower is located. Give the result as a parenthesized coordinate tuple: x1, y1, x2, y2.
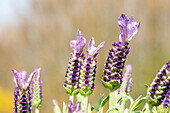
(118, 14, 140, 42)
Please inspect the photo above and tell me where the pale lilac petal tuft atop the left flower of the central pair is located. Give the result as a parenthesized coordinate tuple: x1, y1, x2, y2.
(70, 29, 86, 54)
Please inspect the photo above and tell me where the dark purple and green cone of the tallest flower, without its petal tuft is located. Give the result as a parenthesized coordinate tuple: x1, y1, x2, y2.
(102, 42, 130, 91)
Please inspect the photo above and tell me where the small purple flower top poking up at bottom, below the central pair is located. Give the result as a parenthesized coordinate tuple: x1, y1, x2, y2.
(68, 100, 84, 113)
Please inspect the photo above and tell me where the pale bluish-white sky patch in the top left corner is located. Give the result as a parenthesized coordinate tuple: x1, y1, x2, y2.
(0, 0, 31, 28)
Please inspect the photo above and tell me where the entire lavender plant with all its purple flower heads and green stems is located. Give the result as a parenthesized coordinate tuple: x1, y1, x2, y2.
(12, 14, 170, 113)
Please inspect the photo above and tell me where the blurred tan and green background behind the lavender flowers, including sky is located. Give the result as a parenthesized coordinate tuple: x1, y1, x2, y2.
(0, 0, 170, 113)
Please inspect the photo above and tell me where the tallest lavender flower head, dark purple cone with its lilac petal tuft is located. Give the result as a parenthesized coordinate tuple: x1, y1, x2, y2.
(102, 14, 140, 91)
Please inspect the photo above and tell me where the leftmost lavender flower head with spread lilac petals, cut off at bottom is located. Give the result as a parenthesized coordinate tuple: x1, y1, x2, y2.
(12, 70, 35, 113)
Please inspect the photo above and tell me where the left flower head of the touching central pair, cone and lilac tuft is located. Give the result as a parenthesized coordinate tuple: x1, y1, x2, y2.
(64, 30, 86, 95)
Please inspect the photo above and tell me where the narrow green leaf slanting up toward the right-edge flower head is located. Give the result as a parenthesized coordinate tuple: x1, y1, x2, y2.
(129, 96, 146, 113)
